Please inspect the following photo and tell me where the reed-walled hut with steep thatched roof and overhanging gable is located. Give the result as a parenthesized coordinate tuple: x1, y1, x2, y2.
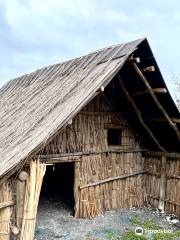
(0, 39, 180, 240)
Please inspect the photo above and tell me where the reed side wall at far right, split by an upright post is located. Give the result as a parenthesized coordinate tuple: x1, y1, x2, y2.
(145, 156, 180, 217)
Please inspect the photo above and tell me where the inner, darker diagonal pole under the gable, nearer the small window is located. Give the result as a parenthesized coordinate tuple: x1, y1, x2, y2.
(117, 75, 166, 152)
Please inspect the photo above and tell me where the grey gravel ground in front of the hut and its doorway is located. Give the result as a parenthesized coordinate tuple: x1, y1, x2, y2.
(35, 199, 177, 240)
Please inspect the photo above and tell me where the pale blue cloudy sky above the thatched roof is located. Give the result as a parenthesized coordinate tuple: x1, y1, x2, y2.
(0, 0, 180, 96)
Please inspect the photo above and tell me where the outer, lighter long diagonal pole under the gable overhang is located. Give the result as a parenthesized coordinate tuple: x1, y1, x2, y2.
(132, 63, 180, 142)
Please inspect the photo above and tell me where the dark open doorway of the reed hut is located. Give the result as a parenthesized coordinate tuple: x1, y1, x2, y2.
(38, 163, 74, 217)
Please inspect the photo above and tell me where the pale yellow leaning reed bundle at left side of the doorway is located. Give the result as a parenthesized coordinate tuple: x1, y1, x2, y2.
(19, 160, 46, 240)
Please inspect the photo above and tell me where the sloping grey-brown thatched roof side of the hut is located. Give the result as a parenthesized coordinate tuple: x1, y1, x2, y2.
(0, 39, 179, 177)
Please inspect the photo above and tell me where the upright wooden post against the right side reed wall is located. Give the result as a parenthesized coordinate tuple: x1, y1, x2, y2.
(158, 156, 166, 212)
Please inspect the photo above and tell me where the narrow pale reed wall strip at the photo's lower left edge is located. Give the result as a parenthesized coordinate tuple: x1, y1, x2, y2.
(0, 181, 12, 240)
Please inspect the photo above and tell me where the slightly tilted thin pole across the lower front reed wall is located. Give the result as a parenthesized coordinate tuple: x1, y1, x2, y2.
(79, 170, 148, 189)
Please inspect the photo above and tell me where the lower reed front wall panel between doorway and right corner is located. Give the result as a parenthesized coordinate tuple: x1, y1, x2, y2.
(75, 153, 145, 218)
